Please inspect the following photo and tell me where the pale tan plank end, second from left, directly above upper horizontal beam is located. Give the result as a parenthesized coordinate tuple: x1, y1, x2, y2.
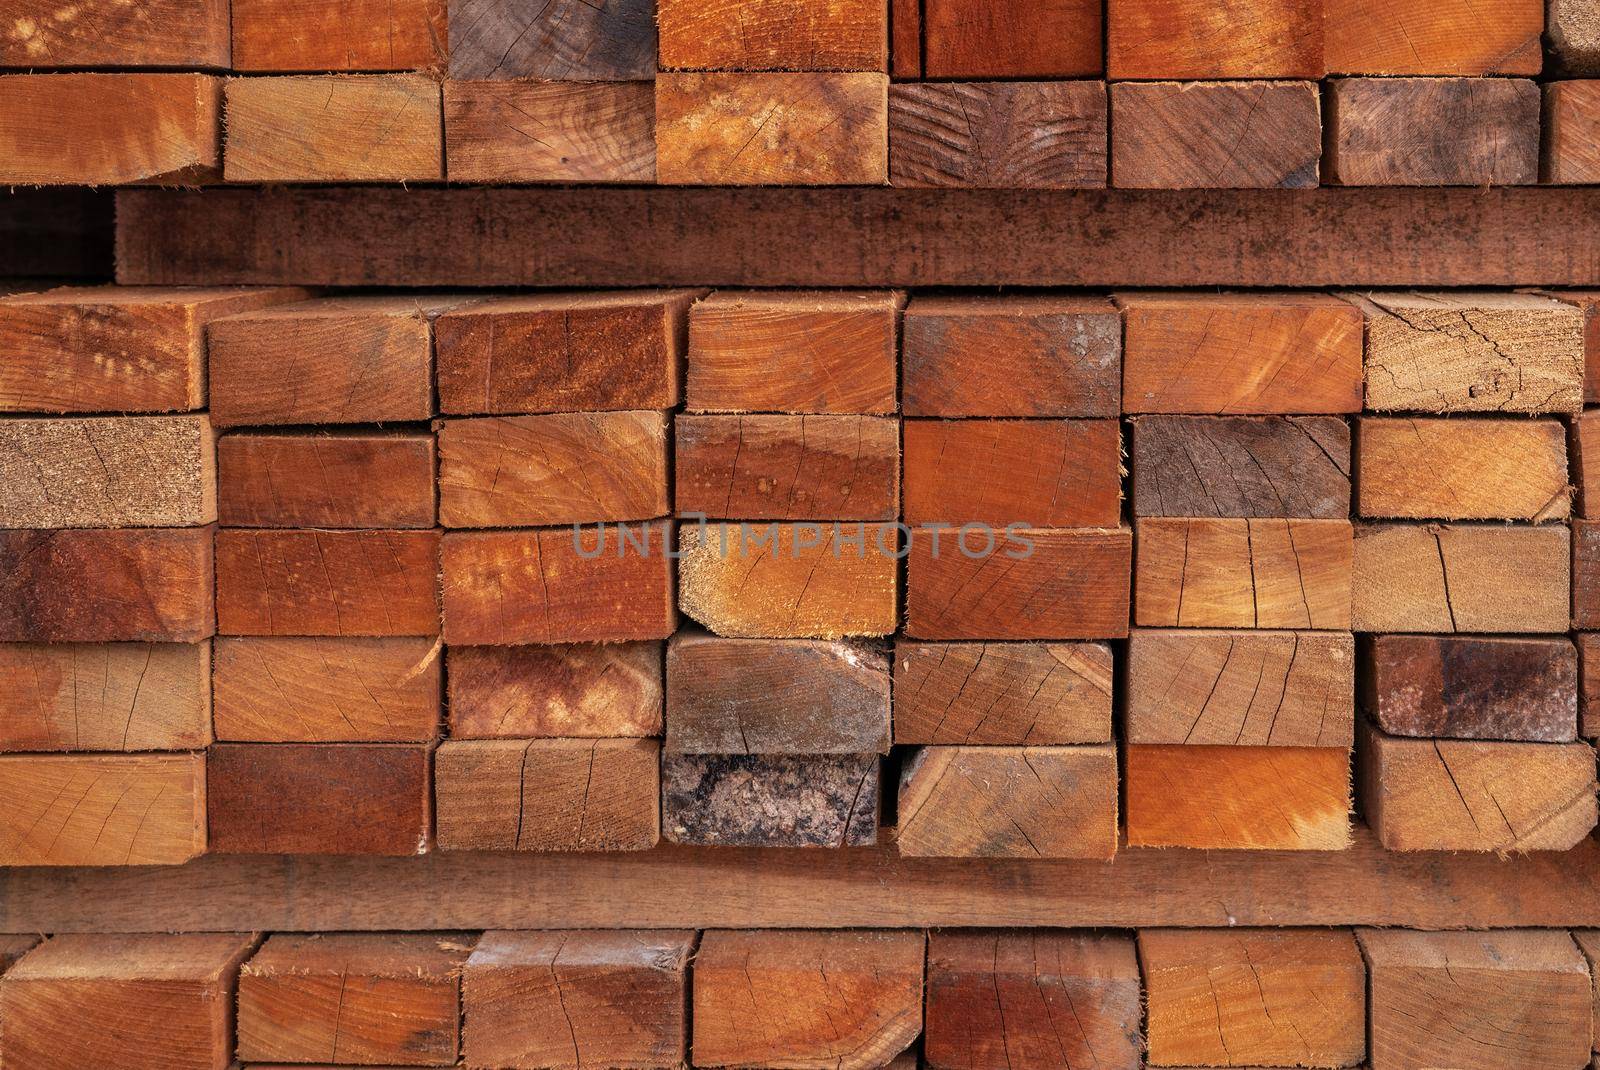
(222, 74, 445, 182)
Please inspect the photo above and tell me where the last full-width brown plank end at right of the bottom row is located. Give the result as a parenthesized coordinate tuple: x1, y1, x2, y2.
(1357, 929, 1590, 1067)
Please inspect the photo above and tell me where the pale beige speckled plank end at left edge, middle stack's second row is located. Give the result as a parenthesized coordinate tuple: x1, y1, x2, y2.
(0, 416, 216, 528)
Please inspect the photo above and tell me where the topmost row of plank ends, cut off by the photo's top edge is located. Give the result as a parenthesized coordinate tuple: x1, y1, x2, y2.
(0, 0, 1600, 80)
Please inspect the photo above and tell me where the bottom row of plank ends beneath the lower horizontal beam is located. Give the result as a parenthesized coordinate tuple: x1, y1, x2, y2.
(0, 929, 1600, 1070)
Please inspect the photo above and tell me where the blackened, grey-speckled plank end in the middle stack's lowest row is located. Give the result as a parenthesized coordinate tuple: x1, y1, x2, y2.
(661, 753, 882, 848)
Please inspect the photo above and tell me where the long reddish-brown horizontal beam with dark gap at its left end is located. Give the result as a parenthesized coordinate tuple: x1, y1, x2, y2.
(117, 187, 1600, 287)
